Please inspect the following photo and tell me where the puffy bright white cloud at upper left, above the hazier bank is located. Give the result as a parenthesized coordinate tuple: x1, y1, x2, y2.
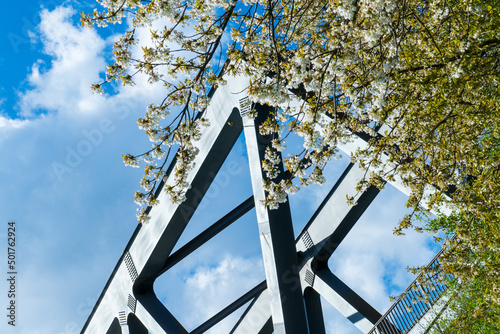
(20, 7, 106, 117)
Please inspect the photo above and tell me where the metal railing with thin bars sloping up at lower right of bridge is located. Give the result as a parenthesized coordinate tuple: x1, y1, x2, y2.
(368, 250, 452, 334)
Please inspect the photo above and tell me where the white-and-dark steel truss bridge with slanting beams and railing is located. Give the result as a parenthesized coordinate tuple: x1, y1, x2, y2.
(81, 73, 446, 334)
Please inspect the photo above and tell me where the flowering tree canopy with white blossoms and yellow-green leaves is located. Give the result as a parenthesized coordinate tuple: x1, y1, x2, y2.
(82, 0, 500, 328)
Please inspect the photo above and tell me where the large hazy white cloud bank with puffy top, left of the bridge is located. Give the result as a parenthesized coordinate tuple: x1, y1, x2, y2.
(0, 7, 167, 334)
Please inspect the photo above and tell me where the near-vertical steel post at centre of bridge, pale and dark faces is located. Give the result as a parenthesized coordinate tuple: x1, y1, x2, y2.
(243, 105, 308, 334)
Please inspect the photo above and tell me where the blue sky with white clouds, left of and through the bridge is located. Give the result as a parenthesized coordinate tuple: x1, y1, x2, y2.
(0, 1, 435, 334)
